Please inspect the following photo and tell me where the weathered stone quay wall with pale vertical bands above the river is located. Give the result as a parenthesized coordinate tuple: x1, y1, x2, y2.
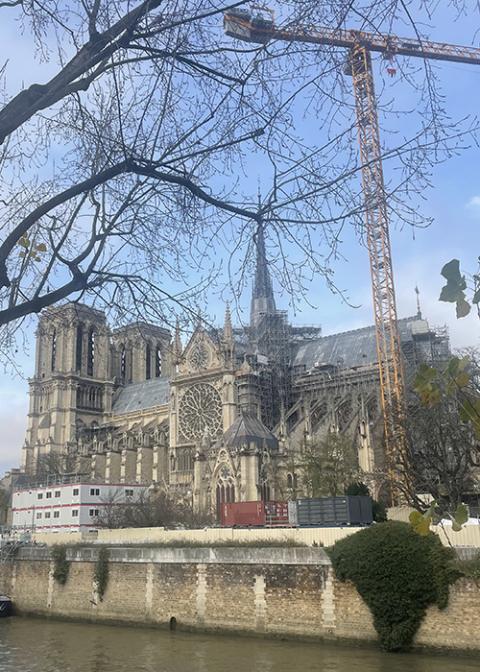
(0, 547, 480, 653)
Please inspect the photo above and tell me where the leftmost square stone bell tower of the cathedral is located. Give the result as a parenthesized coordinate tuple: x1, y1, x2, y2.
(22, 303, 113, 475)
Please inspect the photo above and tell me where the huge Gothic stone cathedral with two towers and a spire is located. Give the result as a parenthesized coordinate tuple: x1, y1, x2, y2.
(22, 228, 448, 512)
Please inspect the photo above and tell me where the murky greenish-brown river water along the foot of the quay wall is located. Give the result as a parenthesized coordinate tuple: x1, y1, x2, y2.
(0, 618, 480, 672)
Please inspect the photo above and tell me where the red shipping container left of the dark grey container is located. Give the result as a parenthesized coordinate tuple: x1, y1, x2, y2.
(220, 501, 288, 527)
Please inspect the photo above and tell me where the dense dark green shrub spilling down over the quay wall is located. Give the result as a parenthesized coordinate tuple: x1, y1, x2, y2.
(328, 521, 459, 651)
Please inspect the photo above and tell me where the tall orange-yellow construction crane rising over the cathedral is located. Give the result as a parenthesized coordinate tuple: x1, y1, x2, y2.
(224, 6, 480, 494)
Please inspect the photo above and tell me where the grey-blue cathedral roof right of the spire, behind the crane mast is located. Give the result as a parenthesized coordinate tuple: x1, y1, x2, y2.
(292, 317, 428, 371)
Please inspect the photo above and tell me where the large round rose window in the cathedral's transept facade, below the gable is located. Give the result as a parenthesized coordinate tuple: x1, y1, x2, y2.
(179, 383, 222, 441)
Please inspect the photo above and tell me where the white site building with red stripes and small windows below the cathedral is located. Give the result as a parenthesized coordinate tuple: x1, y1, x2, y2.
(12, 482, 145, 532)
